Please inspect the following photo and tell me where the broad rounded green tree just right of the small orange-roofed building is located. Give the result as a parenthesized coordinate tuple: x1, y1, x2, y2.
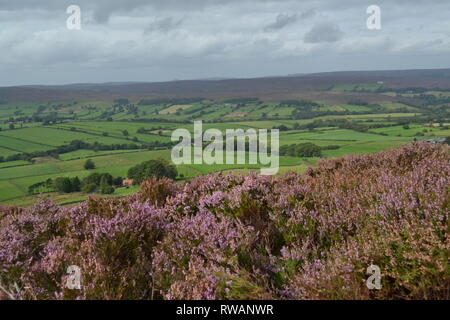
(128, 159, 178, 184)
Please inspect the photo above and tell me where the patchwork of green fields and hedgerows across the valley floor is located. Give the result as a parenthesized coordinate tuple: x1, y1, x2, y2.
(0, 89, 450, 205)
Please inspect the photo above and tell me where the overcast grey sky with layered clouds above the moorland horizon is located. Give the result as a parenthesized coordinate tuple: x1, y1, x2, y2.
(0, 0, 450, 86)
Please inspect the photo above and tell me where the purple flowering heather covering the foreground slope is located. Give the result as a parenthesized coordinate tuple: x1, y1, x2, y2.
(0, 143, 450, 299)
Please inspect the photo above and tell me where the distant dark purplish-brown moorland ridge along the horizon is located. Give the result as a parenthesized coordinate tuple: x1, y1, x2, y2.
(0, 69, 450, 102)
